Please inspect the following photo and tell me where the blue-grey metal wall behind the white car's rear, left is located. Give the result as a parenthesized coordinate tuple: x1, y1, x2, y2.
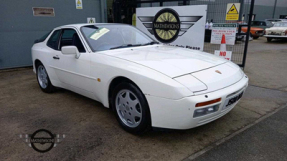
(0, 0, 106, 69)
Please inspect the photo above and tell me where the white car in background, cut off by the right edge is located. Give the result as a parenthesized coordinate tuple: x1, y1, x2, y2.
(264, 22, 287, 42)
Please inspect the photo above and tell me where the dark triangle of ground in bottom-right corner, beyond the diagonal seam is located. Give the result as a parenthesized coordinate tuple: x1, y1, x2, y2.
(195, 103, 287, 161)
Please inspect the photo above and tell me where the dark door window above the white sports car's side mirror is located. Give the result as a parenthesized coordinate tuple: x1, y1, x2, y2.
(60, 29, 86, 53)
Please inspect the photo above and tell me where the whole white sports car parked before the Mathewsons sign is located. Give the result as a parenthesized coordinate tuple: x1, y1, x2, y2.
(32, 24, 248, 133)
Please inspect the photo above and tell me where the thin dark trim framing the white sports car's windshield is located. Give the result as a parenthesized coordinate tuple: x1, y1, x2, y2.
(80, 23, 157, 52)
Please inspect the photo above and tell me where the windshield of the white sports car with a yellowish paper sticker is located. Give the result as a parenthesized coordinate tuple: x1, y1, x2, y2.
(81, 24, 156, 52)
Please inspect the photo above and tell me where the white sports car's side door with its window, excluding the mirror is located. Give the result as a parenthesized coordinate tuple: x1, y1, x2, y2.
(49, 28, 92, 93)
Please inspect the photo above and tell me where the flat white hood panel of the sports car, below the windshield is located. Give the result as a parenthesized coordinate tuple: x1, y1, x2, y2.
(104, 45, 227, 78)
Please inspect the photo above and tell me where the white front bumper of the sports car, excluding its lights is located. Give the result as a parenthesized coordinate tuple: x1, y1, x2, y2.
(146, 76, 248, 129)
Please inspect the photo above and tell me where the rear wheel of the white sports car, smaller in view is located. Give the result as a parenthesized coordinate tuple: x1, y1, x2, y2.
(36, 63, 56, 93)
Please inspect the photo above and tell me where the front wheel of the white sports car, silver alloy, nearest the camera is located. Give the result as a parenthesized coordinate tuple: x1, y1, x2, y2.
(111, 82, 151, 134)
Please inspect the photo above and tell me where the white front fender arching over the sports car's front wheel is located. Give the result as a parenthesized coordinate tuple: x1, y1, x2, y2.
(91, 54, 193, 107)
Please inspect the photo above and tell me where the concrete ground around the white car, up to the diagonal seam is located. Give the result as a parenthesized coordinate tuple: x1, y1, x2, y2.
(0, 38, 287, 160)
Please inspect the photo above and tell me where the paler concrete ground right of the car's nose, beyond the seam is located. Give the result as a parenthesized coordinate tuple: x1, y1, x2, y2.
(245, 38, 287, 91)
